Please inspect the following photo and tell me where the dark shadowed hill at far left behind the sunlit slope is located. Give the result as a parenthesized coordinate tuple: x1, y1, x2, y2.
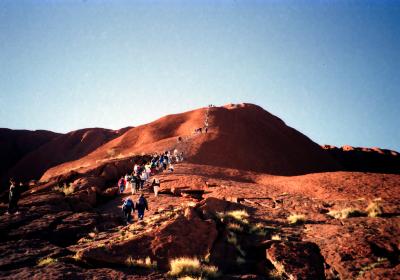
(0, 128, 128, 189)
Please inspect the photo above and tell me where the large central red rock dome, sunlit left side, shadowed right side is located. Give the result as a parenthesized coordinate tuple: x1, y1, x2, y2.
(42, 104, 340, 180)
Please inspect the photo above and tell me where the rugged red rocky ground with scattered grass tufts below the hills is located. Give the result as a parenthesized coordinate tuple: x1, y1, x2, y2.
(0, 162, 400, 279)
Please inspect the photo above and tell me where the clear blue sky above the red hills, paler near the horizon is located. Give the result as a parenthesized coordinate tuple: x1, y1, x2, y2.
(0, 0, 400, 151)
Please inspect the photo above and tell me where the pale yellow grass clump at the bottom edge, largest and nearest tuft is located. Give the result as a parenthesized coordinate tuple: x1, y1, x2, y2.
(169, 257, 218, 279)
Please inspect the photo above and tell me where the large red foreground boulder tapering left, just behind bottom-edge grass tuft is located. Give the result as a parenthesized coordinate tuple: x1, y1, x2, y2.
(78, 205, 217, 270)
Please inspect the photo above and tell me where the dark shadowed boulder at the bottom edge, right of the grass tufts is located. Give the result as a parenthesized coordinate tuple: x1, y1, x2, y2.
(267, 242, 325, 279)
